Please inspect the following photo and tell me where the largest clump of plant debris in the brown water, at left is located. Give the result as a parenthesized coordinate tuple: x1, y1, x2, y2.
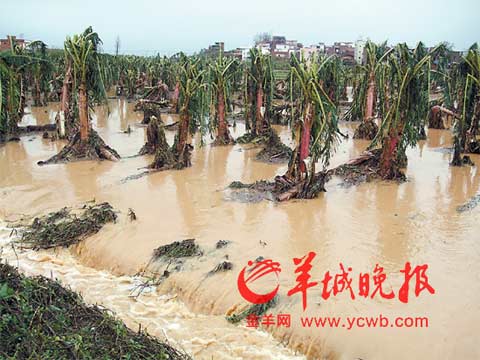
(18, 202, 117, 250)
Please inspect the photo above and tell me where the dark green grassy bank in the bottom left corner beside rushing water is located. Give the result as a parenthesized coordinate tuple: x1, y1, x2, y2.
(0, 264, 190, 360)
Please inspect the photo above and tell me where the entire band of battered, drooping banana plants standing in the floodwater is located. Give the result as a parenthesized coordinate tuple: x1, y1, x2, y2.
(0, 28, 480, 190)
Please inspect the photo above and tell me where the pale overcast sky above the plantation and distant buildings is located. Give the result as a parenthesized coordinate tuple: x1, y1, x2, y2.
(0, 0, 480, 55)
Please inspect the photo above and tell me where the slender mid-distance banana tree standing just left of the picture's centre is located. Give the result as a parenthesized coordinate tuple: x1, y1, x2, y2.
(208, 54, 238, 145)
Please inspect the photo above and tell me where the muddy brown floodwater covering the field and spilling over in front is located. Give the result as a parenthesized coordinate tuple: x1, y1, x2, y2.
(0, 100, 480, 360)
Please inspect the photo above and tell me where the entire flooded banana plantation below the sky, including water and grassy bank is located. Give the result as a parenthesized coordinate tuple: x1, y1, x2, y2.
(0, 2, 480, 360)
